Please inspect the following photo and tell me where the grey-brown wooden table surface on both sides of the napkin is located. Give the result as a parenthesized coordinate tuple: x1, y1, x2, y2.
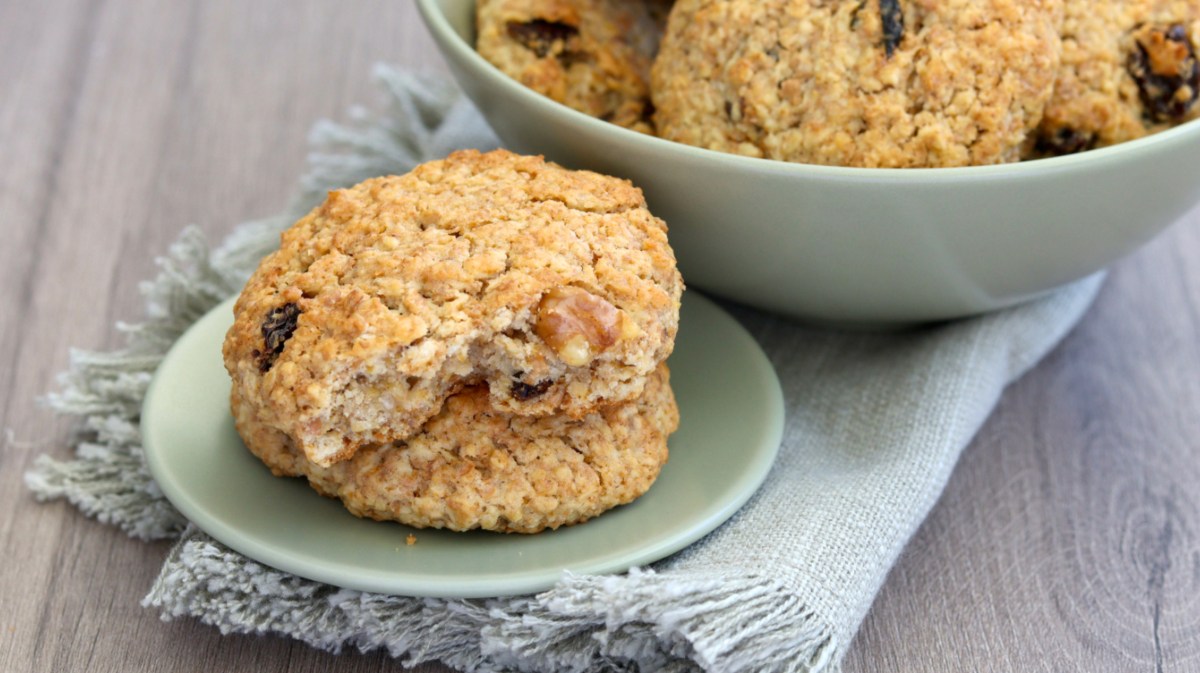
(0, 0, 1200, 673)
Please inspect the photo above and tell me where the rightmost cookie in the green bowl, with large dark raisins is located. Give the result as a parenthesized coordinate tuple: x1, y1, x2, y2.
(1030, 0, 1200, 157)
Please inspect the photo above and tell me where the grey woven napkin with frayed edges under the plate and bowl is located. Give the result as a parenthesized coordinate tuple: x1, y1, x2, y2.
(26, 67, 1100, 673)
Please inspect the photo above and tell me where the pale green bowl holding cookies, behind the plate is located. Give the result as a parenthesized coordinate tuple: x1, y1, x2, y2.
(419, 0, 1200, 325)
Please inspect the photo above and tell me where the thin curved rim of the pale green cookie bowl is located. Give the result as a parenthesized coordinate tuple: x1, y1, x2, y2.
(416, 0, 1200, 184)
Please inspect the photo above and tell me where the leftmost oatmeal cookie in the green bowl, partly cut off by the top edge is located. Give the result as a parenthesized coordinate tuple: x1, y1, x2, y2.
(475, 0, 670, 133)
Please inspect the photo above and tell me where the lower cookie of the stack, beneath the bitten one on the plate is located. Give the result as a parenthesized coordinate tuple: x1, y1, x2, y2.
(233, 365, 679, 533)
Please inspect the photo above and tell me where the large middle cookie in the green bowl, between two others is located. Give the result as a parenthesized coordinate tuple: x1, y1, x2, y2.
(653, 0, 1062, 167)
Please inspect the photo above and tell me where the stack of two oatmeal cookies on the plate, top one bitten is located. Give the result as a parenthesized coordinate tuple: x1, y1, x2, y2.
(223, 151, 683, 533)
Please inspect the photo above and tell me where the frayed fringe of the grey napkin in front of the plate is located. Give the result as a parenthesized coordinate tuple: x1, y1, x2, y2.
(142, 525, 841, 673)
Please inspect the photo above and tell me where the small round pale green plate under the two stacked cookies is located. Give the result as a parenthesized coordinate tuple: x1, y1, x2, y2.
(142, 293, 784, 597)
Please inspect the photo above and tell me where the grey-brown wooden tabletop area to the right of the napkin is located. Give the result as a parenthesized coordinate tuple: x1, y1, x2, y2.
(846, 211, 1200, 673)
